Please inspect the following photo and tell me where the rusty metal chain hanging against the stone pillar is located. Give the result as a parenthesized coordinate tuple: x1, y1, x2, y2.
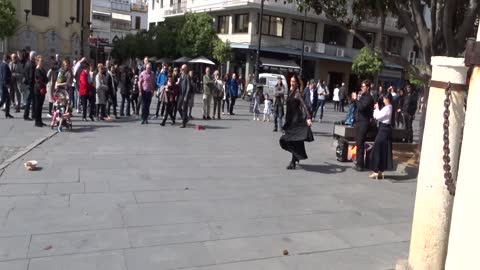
(443, 82, 456, 196)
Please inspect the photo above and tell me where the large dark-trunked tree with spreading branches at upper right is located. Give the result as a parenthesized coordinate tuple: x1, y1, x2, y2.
(298, 0, 480, 81)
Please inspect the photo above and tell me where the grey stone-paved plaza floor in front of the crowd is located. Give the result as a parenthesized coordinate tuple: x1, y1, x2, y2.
(0, 96, 416, 270)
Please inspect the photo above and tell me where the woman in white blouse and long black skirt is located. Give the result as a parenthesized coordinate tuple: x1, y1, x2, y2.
(370, 93, 393, 179)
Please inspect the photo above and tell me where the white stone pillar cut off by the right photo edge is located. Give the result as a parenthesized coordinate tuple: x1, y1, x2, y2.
(446, 29, 480, 270)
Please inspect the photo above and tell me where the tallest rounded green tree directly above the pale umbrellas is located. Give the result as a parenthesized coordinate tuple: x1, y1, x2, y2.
(176, 13, 216, 57)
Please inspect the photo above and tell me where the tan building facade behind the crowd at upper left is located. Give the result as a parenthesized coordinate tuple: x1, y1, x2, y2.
(4, 0, 91, 58)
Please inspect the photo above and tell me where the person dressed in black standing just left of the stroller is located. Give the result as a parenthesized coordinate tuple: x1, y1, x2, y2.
(33, 55, 48, 127)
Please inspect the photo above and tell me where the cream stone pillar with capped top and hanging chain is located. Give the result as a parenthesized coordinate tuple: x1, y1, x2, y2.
(408, 57, 467, 270)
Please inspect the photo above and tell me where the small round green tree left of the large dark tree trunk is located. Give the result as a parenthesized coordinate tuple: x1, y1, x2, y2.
(352, 47, 383, 80)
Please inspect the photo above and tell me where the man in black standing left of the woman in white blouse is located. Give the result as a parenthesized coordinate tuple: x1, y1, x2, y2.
(355, 80, 374, 171)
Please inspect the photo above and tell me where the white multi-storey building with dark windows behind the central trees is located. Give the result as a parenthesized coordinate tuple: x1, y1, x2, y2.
(148, 0, 413, 87)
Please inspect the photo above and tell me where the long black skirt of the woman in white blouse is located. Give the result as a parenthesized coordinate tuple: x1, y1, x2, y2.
(370, 123, 393, 172)
